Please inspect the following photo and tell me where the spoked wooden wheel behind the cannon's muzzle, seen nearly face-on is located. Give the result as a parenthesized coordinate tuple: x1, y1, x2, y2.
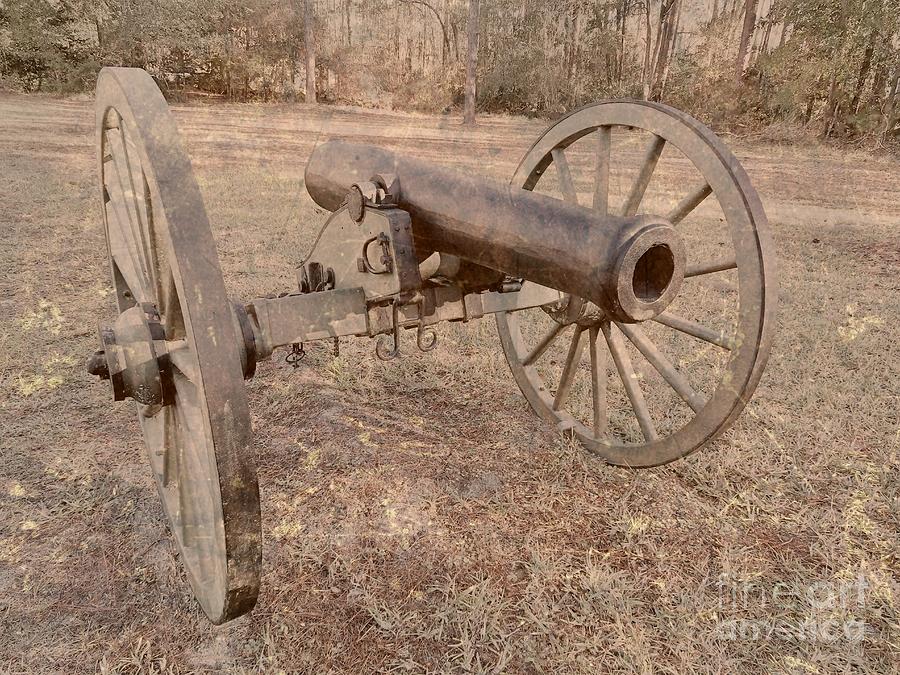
(497, 101, 777, 467)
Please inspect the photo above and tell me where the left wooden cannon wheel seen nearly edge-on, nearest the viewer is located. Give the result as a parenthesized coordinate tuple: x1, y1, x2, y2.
(96, 68, 261, 623)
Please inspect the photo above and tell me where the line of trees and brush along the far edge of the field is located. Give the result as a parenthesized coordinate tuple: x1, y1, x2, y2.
(0, 0, 900, 141)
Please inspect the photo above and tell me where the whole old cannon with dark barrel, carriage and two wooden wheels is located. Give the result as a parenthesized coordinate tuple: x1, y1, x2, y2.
(82, 68, 777, 623)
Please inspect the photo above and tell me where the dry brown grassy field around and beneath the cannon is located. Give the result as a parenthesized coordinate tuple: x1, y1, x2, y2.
(0, 95, 900, 673)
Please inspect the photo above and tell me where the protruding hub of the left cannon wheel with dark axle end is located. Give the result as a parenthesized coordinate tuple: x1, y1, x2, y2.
(87, 304, 173, 405)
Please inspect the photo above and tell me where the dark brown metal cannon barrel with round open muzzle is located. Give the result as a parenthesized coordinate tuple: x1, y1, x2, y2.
(305, 141, 685, 322)
